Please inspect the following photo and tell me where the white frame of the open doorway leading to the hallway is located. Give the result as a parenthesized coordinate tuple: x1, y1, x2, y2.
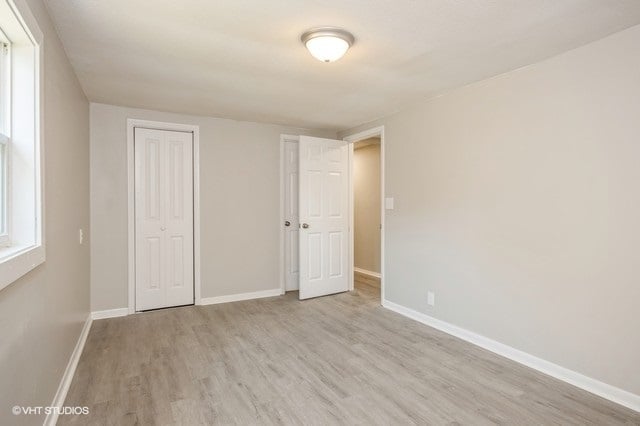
(343, 126, 386, 305)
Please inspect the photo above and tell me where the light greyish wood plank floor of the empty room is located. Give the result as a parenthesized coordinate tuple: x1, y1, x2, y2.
(58, 282, 640, 425)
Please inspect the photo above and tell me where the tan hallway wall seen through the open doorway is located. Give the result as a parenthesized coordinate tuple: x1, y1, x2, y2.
(353, 138, 380, 272)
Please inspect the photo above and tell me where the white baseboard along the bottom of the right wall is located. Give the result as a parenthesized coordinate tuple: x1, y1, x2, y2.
(382, 300, 640, 412)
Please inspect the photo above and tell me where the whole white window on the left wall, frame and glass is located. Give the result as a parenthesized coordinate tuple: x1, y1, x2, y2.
(0, 0, 45, 290)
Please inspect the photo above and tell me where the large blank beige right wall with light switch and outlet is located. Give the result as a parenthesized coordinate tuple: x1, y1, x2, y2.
(344, 26, 640, 394)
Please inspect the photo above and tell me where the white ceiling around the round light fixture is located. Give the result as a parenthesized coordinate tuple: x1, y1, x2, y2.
(45, 0, 640, 129)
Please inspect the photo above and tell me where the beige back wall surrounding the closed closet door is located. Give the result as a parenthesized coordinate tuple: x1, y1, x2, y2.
(91, 104, 335, 311)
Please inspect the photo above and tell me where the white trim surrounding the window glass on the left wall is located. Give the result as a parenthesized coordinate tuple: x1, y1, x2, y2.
(0, 0, 46, 290)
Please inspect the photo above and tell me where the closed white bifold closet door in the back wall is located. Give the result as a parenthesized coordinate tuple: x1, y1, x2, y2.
(134, 128, 194, 311)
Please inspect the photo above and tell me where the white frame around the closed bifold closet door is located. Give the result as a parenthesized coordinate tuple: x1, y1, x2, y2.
(127, 118, 202, 314)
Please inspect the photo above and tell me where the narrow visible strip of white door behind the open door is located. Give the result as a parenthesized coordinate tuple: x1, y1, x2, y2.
(283, 141, 300, 291)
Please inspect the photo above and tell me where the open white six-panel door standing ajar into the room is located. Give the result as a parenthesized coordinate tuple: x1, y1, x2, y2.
(299, 136, 350, 299)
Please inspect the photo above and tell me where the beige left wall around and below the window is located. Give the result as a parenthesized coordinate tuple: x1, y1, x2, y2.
(0, 0, 89, 425)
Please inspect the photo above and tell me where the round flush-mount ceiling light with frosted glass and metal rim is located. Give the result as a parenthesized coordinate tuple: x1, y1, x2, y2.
(300, 27, 355, 62)
